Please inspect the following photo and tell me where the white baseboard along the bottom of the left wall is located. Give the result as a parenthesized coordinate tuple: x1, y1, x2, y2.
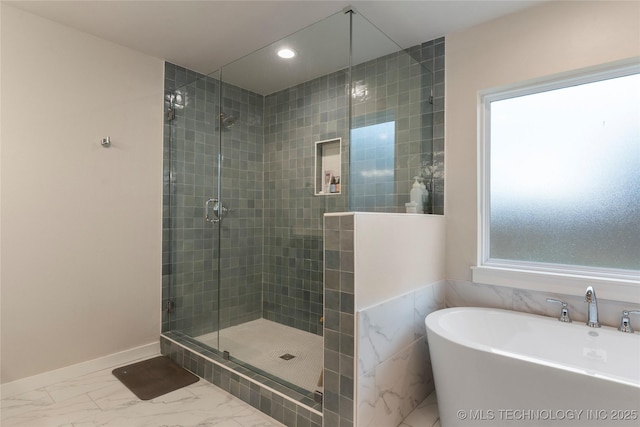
(0, 341, 160, 399)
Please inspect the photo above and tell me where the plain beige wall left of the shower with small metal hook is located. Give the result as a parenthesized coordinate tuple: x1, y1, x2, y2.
(0, 3, 163, 383)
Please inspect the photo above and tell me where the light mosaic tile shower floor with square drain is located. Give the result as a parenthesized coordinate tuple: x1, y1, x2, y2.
(195, 319, 323, 391)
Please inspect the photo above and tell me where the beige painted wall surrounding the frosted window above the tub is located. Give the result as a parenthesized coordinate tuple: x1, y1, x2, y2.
(445, 1, 640, 281)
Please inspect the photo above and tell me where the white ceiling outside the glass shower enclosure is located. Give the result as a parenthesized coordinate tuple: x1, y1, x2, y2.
(4, 0, 545, 94)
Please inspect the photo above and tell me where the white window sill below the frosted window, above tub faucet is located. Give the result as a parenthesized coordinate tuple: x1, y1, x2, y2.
(471, 266, 640, 304)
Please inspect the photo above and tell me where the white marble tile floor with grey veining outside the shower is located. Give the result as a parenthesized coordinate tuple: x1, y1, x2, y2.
(0, 362, 440, 427)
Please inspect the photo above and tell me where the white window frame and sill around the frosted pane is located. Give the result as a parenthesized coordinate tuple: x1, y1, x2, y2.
(472, 58, 640, 303)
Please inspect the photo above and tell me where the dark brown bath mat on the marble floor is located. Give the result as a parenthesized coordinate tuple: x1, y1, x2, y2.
(112, 356, 199, 400)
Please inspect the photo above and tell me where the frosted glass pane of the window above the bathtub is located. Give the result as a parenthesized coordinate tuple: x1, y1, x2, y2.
(484, 71, 640, 270)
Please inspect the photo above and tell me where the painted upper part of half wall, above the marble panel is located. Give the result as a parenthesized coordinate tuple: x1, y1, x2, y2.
(354, 212, 445, 312)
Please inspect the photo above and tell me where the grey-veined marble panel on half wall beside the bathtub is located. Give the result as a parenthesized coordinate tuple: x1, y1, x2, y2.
(356, 281, 446, 426)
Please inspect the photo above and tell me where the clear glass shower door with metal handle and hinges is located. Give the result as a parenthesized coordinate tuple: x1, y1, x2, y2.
(163, 64, 220, 348)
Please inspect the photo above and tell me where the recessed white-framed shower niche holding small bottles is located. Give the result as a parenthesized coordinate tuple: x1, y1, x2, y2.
(315, 138, 342, 196)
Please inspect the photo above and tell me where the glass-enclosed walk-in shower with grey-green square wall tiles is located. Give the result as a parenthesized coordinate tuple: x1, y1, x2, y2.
(163, 5, 433, 425)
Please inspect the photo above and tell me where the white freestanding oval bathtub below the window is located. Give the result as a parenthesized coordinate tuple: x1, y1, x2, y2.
(425, 307, 640, 427)
